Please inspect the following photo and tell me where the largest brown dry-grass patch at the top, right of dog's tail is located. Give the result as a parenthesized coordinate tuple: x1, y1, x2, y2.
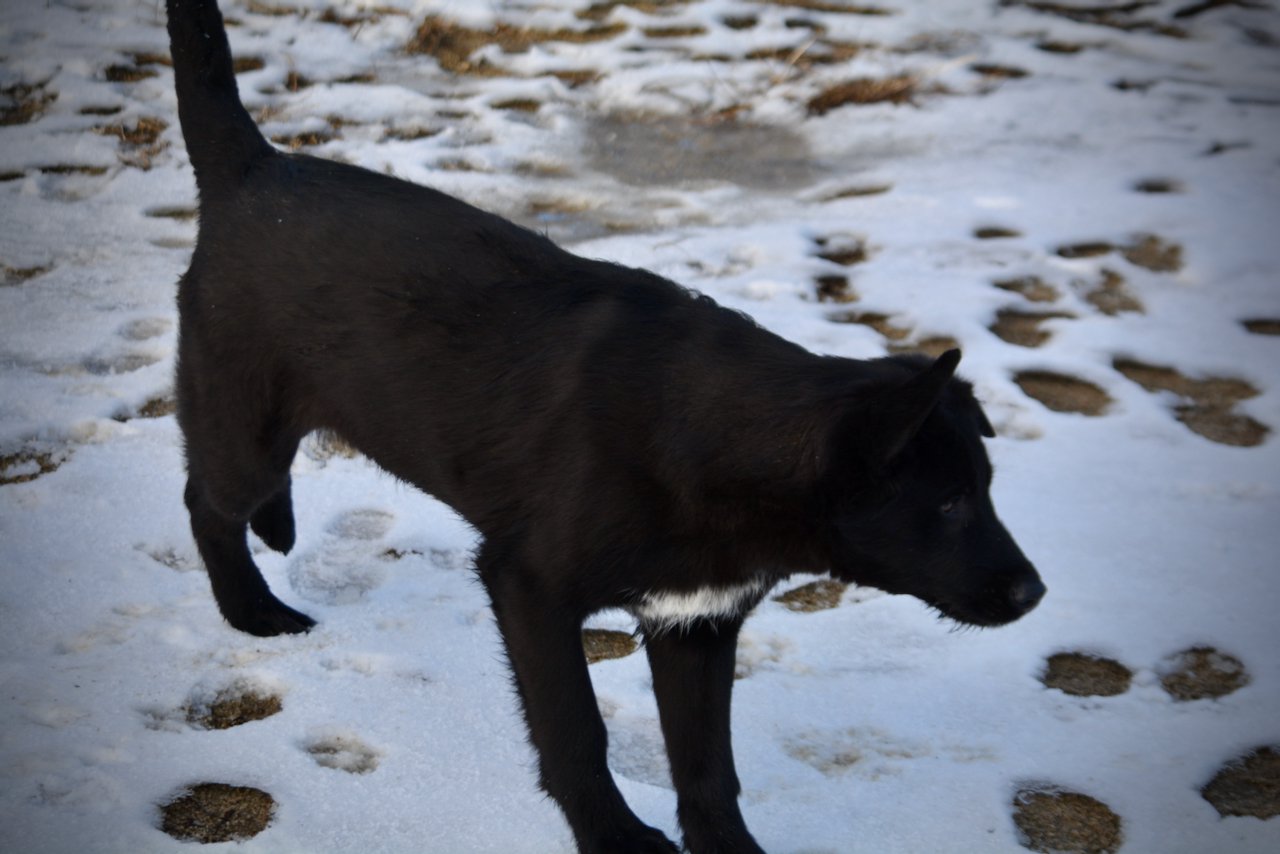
(407, 15, 627, 76)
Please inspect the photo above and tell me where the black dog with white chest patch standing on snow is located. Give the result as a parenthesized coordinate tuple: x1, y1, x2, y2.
(168, 0, 1044, 854)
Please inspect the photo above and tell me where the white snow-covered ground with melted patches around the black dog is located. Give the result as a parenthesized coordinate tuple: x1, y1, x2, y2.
(0, 0, 1280, 854)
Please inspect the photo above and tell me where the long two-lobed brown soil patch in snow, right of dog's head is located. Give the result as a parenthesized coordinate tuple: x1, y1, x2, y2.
(1112, 359, 1271, 448)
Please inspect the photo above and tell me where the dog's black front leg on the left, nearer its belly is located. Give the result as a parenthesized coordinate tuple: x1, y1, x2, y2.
(476, 545, 678, 854)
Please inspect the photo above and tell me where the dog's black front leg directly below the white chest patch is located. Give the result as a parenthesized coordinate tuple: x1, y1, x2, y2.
(645, 618, 764, 854)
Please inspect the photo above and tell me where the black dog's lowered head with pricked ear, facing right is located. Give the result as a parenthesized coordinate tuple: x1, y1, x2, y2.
(828, 350, 1044, 626)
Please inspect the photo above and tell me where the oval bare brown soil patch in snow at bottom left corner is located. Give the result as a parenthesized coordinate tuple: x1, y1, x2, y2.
(160, 782, 275, 844)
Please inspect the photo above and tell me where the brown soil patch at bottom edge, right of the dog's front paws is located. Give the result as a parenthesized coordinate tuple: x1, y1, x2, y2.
(1014, 787, 1124, 854)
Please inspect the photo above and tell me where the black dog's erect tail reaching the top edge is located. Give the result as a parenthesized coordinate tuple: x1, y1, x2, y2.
(165, 0, 275, 196)
